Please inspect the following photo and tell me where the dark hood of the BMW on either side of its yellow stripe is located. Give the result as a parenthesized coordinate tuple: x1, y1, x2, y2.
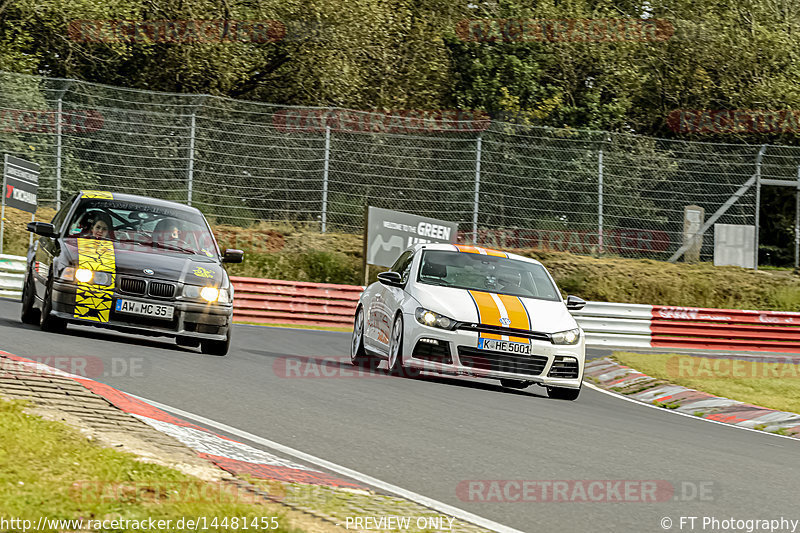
(62, 238, 227, 287)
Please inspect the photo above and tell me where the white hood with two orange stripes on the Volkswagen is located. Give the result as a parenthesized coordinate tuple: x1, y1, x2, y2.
(413, 285, 578, 333)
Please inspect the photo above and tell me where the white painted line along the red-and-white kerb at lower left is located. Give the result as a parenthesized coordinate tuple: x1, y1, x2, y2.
(123, 391, 522, 533)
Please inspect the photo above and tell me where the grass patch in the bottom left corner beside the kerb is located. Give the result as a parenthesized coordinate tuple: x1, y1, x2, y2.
(0, 400, 310, 532)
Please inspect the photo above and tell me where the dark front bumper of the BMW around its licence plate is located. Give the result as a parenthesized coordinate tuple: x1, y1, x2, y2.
(53, 281, 233, 340)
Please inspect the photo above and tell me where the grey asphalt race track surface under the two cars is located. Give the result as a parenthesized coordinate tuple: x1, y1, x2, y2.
(0, 299, 800, 533)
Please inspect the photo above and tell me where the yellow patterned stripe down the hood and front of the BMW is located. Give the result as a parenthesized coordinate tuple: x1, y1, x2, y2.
(73, 239, 117, 322)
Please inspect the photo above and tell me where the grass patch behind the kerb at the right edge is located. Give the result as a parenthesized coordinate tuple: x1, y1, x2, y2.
(613, 352, 800, 413)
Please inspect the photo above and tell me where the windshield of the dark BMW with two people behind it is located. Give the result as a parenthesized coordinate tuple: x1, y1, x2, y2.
(67, 198, 219, 258)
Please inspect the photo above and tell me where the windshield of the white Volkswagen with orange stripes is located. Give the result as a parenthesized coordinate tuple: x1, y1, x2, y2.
(417, 250, 561, 301)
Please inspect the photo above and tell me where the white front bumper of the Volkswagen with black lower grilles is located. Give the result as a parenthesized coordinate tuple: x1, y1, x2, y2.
(403, 315, 586, 389)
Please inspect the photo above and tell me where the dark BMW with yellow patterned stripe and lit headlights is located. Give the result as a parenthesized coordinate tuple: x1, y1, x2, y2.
(22, 191, 243, 355)
